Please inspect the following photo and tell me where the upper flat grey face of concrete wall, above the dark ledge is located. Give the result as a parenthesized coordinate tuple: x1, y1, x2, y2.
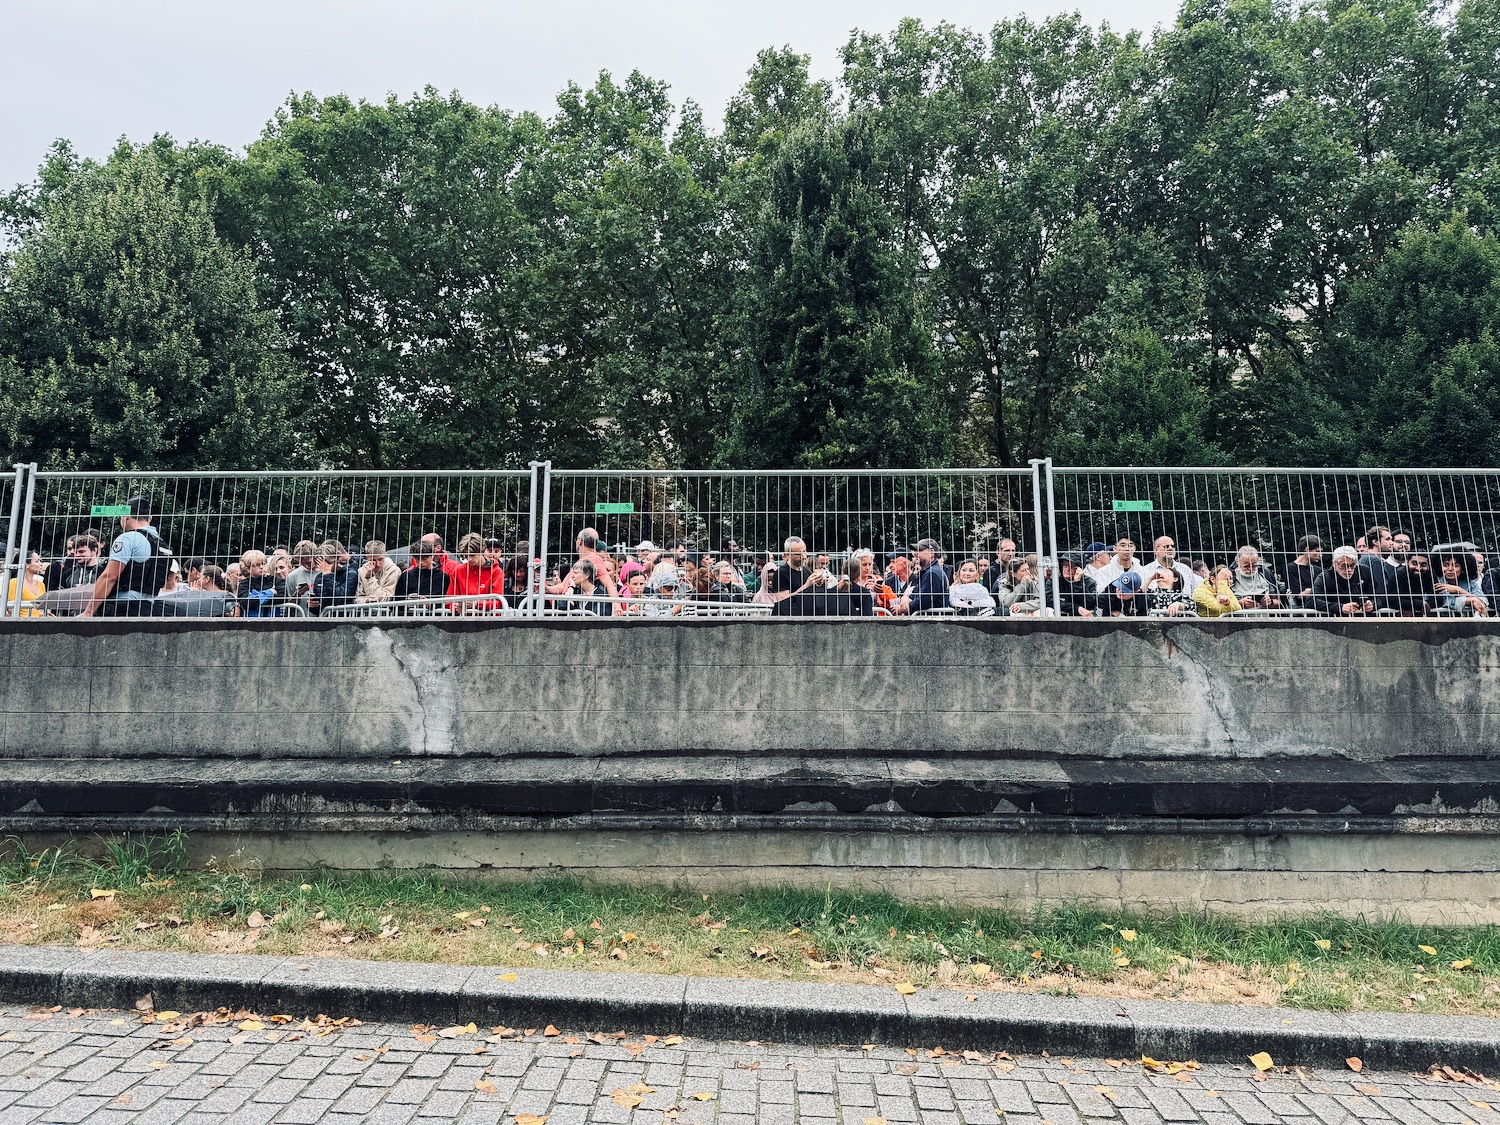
(0, 620, 1500, 762)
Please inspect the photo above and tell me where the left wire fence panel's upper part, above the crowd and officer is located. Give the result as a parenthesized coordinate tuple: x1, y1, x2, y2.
(32, 471, 533, 567)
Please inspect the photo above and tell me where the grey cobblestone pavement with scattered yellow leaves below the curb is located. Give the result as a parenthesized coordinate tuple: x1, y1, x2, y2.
(0, 1008, 1500, 1125)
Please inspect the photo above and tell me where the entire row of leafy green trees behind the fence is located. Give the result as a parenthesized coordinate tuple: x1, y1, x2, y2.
(0, 0, 1500, 468)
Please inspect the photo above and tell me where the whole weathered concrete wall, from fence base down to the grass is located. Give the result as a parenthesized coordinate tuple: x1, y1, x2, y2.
(0, 620, 1500, 923)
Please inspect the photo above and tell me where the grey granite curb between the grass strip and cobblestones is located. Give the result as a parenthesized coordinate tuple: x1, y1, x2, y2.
(0, 945, 1500, 1074)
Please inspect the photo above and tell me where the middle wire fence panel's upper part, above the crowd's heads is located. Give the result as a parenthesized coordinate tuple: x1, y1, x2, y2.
(545, 470, 1041, 573)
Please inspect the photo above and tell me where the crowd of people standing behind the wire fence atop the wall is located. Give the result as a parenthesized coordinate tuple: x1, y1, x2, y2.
(8, 497, 1500, 618)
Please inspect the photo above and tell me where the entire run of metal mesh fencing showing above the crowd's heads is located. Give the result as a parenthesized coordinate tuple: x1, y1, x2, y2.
(0, 461, 1500, 627)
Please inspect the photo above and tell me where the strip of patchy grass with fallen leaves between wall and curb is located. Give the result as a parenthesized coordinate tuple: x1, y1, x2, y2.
(0, 837, 1500, 1014)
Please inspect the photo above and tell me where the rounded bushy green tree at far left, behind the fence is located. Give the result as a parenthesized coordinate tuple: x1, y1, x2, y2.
(0, 143, 294, 470)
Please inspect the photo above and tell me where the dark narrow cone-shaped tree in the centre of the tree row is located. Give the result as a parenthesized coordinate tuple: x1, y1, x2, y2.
(732, 114, 951, 468)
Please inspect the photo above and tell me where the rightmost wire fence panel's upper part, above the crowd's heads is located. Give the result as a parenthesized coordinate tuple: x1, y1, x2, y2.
(1053, 467, 1500, 576)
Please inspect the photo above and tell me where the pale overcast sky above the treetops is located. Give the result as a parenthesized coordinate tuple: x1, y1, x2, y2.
(0, 0, 1178, 189)
